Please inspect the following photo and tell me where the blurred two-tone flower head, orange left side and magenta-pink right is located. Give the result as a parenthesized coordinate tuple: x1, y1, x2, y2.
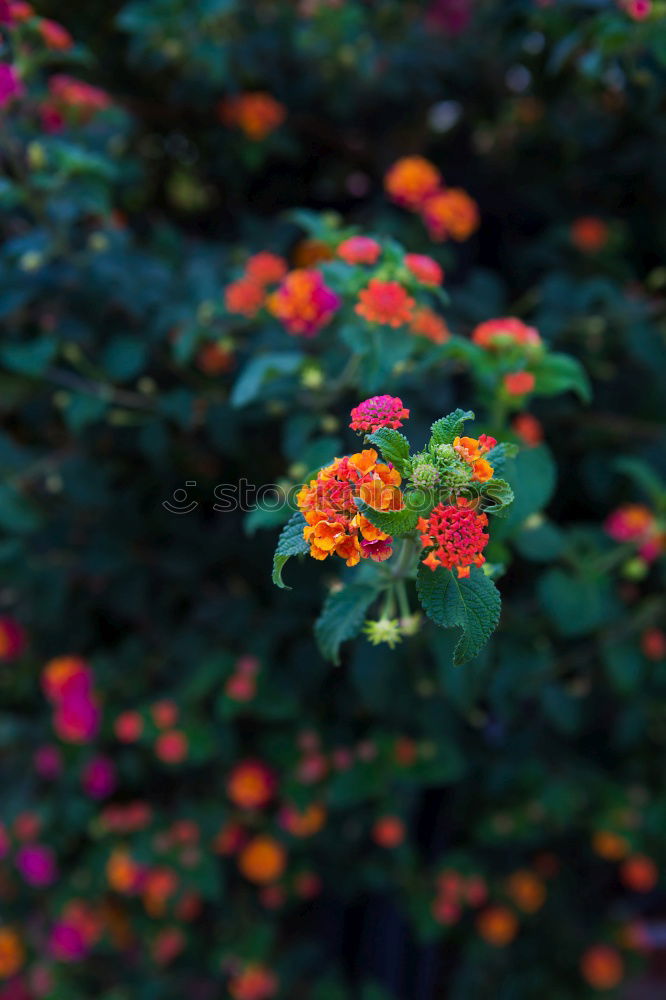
(266, 269, 340, 337)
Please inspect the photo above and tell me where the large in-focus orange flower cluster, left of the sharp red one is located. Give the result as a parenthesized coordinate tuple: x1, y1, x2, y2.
(297, 448, 403, 566)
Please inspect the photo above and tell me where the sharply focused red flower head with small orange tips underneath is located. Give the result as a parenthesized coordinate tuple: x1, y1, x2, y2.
(418, 497, 489, 579)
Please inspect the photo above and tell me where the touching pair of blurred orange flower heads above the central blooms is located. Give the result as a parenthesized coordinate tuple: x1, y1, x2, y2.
(384, 156, 479, 242)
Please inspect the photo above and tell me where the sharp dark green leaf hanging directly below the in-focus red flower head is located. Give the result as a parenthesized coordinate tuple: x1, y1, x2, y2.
(416, 563, 501, 666)
